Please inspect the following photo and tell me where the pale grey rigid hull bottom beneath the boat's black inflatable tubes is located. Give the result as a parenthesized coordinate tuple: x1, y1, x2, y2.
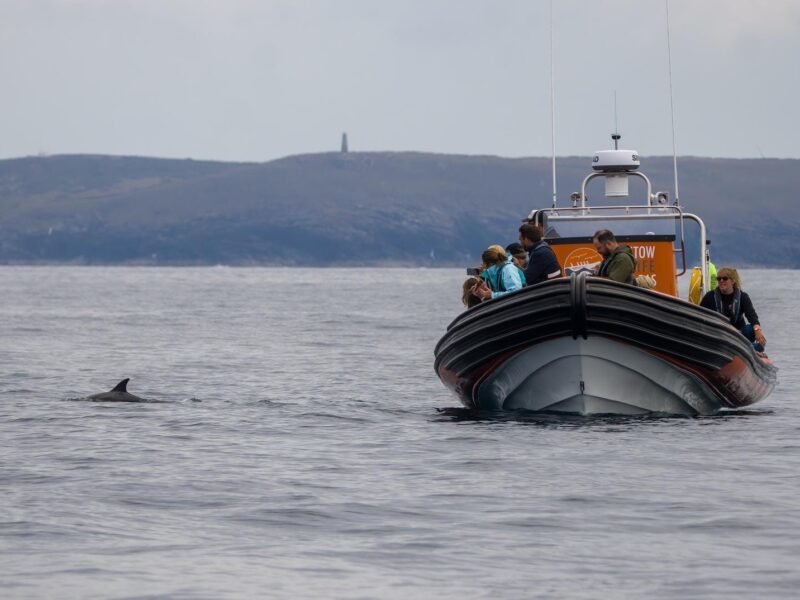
(474, 336, 723, 415)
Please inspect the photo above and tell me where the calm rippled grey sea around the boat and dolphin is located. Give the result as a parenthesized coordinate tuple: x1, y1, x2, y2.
(0, 267, 800, 598)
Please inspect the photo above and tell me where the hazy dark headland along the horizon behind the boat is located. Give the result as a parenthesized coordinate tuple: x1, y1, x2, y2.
(0, 153, 800, 268)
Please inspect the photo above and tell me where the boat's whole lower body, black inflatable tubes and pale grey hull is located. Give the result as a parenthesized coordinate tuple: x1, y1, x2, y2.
(435, 275, 776, 415)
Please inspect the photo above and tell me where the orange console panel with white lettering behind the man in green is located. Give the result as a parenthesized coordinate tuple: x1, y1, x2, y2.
(550, 240, 678, 296)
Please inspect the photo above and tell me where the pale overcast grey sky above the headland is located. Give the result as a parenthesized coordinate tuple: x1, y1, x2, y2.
(0, 0, 800, 162)
